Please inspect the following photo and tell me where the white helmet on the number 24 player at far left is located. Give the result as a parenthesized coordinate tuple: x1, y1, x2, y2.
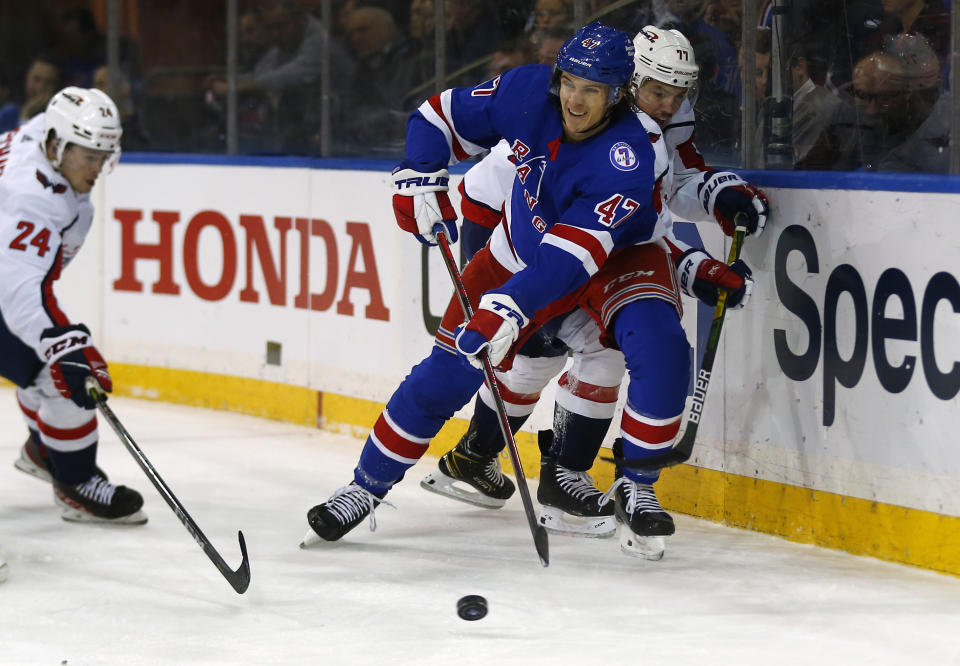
(43, 86, 123, 169)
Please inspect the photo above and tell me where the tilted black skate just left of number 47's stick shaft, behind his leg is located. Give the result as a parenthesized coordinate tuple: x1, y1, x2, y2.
(420, 437, 516, 509)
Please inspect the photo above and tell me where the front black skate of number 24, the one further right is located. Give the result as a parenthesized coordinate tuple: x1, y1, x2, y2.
(53, 472, 147, 525)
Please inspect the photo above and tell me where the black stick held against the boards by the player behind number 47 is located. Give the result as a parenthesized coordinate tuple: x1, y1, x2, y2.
(602, 220, 747, 470)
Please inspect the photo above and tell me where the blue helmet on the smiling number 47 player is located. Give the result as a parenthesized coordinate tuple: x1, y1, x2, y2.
(551, 21, 634, 104)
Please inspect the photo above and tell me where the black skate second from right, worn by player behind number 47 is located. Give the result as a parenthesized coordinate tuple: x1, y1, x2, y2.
(537, 458, 617, 538)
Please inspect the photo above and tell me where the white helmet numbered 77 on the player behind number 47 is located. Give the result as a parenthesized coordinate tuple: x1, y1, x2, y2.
(630, 25, 700, 94)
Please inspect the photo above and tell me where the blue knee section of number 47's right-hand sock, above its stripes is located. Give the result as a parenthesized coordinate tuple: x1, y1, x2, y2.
(614, 299, 690, 418)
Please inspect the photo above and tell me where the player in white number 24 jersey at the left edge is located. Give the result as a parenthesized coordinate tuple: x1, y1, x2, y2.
(0, 87, 147, 524)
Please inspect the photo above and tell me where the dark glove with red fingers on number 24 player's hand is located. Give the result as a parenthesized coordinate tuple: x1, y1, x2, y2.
(40, 324, 113, 409)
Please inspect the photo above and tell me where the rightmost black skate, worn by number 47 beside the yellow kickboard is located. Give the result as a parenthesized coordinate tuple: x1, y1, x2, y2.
(607, 477, 676, 561)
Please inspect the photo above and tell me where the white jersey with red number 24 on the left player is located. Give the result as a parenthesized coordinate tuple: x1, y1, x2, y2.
(0, 113, 93, 358)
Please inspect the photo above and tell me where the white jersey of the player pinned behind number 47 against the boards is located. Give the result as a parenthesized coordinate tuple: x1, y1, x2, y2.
(463, 100, 714, 255)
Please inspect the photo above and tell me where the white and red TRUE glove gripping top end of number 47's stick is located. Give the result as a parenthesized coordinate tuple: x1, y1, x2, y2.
(393, 164, 457, 245)
